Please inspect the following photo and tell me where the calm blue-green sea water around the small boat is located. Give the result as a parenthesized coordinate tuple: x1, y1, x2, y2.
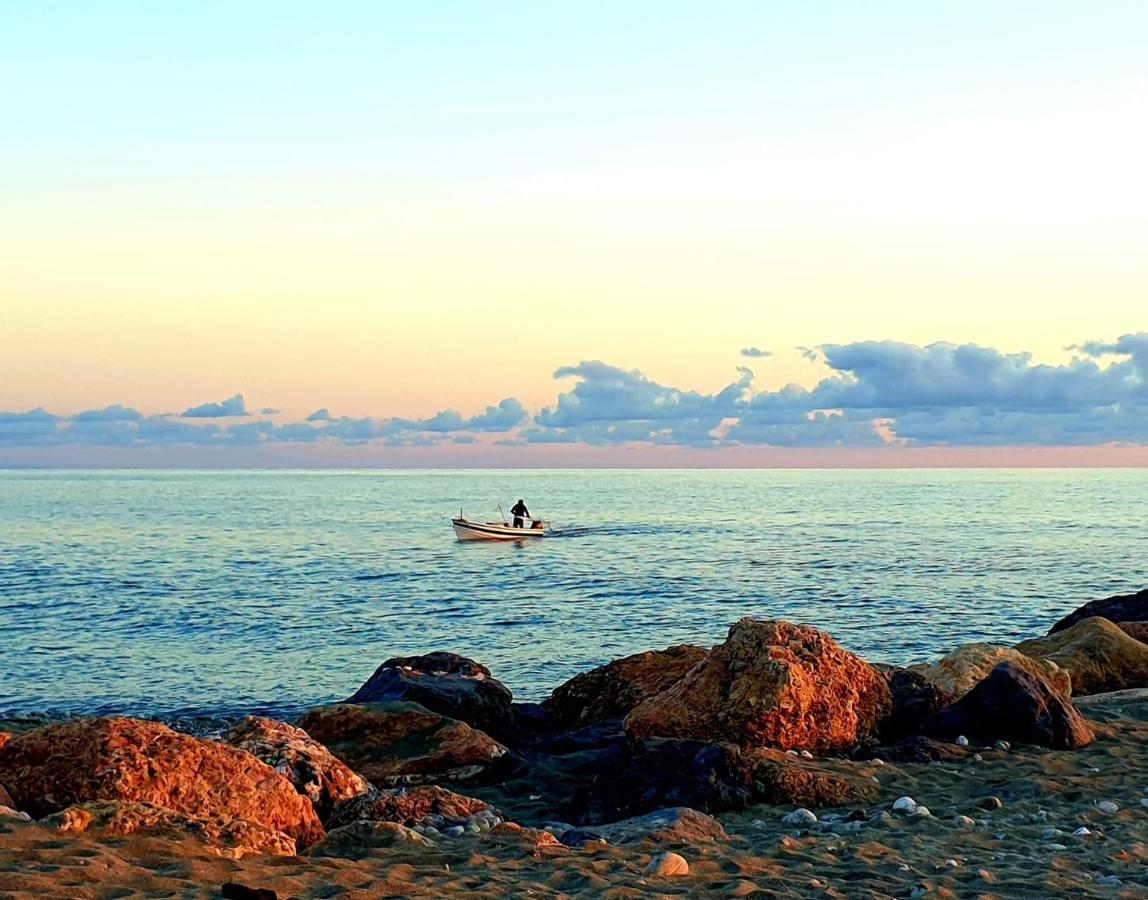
(0, 471, 1148, 715)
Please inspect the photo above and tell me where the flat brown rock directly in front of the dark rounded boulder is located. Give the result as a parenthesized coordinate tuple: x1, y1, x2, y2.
(300, 703, 506, 785)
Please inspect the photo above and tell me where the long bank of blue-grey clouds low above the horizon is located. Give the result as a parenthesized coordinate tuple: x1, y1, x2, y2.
(0, 332, 1148, 448)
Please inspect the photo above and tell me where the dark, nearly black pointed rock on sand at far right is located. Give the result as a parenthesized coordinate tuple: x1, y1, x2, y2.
(924, 662, 1095, 750)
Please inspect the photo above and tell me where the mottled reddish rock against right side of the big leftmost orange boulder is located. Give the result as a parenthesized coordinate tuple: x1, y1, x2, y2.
(223, 715, 371, 821)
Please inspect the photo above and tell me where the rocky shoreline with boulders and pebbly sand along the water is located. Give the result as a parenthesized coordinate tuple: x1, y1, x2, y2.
(0, 590, 1148, 898)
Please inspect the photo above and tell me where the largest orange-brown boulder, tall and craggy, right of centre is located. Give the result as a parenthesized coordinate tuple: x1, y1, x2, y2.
(626, 619, 892, 753)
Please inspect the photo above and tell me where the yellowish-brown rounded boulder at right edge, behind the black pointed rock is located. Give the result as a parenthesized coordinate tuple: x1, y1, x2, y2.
(1016, 618, 1148, 695)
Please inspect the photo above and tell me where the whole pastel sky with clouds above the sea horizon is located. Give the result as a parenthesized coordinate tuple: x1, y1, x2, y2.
(0, 0, 1148, 466)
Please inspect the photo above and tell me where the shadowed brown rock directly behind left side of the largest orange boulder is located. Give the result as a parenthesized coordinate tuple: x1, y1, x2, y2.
(542, 644, 707, 729)
